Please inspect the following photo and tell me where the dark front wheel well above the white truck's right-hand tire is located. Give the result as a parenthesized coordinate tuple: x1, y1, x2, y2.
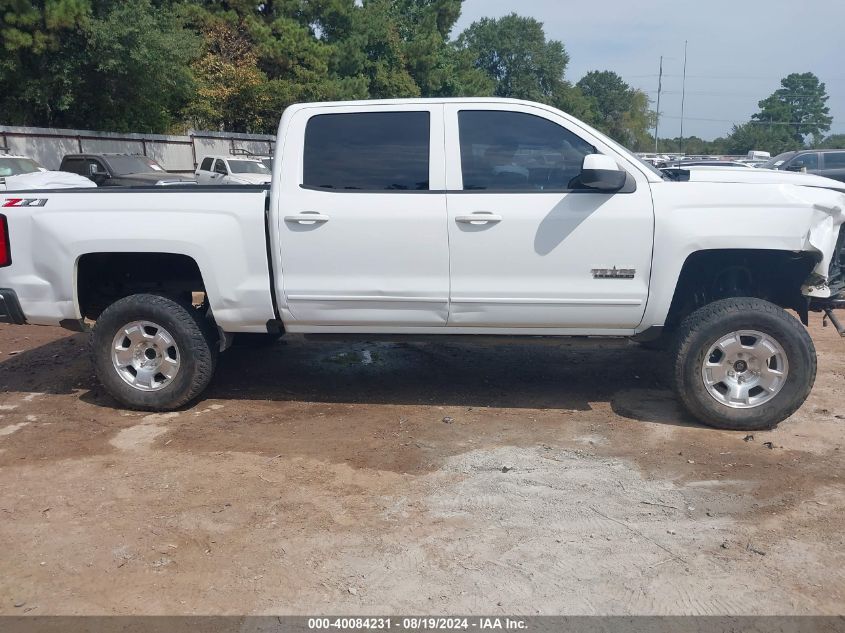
(666, 249, 818, 329)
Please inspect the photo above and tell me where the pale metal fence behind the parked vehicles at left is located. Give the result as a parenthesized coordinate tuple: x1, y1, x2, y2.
(0, 126, 276, 173)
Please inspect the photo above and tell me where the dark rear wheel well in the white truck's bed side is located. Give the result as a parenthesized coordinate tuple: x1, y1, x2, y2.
(76, 253, 205, 320)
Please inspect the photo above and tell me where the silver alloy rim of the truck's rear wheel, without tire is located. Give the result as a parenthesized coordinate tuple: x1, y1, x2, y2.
(112, 321, 181, 391)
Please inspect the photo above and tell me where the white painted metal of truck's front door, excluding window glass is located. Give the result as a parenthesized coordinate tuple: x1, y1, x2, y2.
(438, 103, 654, 330)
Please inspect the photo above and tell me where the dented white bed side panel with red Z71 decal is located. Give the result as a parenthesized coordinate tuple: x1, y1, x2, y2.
(0, 190, 273, 332)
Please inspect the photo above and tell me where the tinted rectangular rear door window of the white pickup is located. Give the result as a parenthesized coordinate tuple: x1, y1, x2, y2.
(303, 112, 431, 191)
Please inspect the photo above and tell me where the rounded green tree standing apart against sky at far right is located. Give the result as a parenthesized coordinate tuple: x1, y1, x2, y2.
(751, 72, 833, 147)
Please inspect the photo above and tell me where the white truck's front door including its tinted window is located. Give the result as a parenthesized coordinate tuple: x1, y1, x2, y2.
(445, 103, 654, 333)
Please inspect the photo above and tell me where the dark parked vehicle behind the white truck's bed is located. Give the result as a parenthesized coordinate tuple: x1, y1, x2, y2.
(60, 154, 197, 187)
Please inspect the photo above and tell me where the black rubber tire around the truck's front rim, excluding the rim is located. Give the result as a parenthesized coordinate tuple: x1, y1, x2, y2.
(673, 297, 816, 431)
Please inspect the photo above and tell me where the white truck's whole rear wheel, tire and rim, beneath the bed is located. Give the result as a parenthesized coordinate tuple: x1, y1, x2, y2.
(91, 294, 217, 411)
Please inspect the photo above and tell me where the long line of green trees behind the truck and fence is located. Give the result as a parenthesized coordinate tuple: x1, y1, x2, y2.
(0, 0, 830, 153)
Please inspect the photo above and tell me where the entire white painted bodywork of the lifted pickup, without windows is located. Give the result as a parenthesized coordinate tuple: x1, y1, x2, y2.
(0, 99, 845, 336)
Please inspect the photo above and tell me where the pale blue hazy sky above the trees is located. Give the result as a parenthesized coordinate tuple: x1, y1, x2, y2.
(453, 0, 845, 140)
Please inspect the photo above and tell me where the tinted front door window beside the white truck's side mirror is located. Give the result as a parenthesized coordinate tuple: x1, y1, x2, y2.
(458, 110, 595, 191)
